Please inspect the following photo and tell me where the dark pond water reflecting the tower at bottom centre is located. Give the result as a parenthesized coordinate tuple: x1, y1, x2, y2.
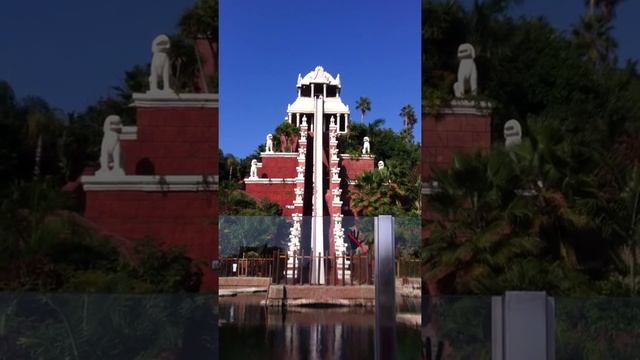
(219, 295, 420, 360)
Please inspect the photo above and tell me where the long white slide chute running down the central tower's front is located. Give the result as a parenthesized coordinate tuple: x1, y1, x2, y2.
(311, 96, 325, 284)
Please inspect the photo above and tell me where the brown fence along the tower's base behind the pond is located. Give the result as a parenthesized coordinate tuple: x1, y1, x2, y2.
(220, 251, 420, 285)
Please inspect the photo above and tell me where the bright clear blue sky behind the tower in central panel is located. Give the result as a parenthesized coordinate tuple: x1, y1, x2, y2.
(220, 0, 421, 156)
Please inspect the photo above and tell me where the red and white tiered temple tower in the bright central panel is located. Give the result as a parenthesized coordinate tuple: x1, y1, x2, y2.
(244, 66, 374, 284)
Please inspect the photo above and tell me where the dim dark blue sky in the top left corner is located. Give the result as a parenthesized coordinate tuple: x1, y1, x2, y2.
(0, 0, 194, 111)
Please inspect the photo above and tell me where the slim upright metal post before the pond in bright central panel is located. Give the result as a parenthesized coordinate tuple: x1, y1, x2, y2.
(374, 215, 396, 360)
